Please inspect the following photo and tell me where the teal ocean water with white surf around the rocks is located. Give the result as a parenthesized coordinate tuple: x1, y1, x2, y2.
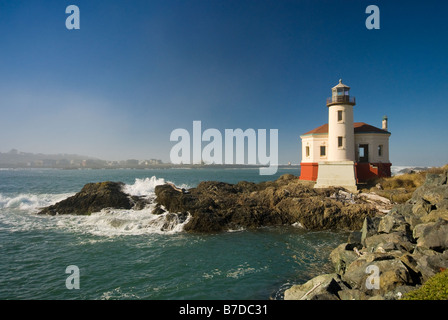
(0, 168, 347, 300)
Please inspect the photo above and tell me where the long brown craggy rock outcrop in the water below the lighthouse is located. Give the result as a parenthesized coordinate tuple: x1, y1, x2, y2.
(153, 175, 391, 232)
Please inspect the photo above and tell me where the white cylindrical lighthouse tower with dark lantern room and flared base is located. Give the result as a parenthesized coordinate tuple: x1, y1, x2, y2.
(315, 80, 357, 191)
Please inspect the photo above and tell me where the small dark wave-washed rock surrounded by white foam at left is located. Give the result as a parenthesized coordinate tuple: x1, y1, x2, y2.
(38, 181, 147, 215)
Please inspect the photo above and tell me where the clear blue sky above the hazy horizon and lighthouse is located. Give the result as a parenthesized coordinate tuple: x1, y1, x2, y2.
(0, 0, 448, 166)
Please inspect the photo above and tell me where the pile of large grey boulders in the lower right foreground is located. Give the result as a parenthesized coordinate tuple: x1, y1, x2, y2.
(285, 172, 448, 300)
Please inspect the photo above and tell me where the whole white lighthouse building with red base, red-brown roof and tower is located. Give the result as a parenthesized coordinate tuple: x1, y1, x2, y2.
(300, 79, 391, 192)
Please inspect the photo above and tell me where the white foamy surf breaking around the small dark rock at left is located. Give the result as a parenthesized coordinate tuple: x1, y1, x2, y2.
(0, 176, 190, 236)
